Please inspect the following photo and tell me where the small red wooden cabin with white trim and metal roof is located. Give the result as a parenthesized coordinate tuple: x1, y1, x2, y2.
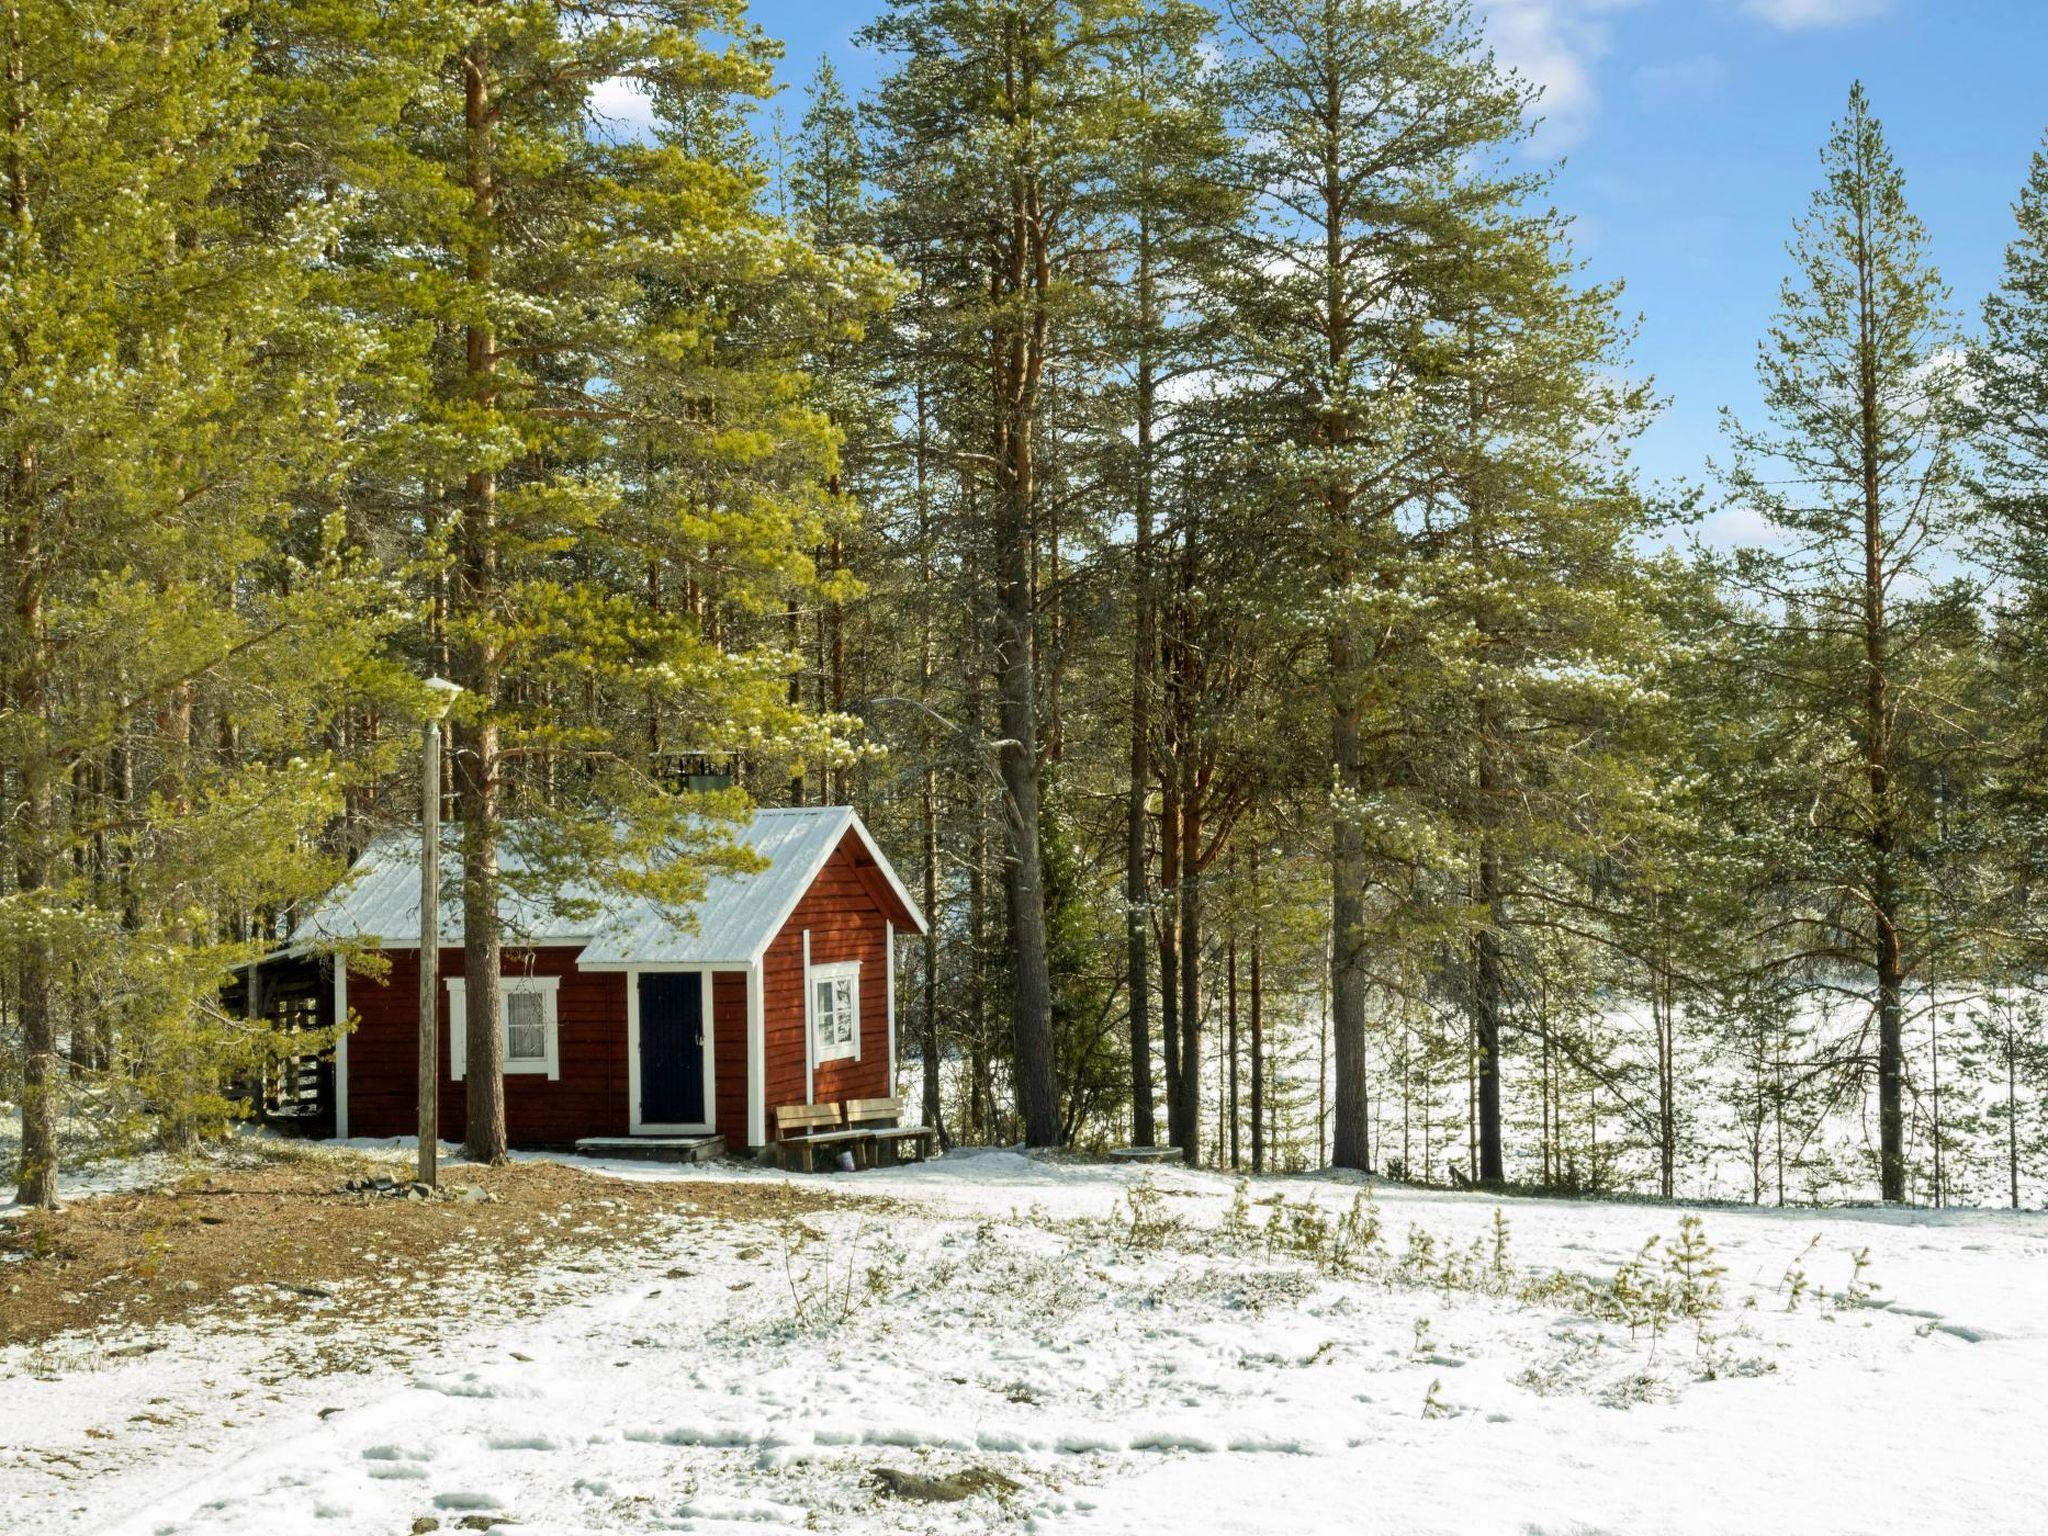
(256, 807, 926, 1147)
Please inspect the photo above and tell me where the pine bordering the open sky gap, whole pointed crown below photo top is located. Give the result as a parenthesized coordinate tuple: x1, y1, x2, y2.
(1405, 188, 1655, 1182)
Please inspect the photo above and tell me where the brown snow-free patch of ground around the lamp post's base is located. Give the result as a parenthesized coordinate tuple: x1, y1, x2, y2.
(0, 1149, 844, 1370)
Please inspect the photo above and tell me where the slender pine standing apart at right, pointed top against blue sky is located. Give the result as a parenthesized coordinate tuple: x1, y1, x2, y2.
(1729, 86, 1970, 1200)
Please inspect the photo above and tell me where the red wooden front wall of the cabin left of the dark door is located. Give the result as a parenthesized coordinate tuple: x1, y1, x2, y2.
(348, 946, 622, 1147)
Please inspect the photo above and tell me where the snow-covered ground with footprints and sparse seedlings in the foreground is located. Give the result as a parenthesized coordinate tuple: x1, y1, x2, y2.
(0, 1153, 2048, 1536)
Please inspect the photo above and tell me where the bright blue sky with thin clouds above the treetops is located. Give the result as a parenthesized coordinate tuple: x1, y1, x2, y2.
(752, 0, 2048, 539)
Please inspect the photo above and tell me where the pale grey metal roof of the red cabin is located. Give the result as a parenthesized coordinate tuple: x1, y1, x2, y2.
(291, 805, 924, 967)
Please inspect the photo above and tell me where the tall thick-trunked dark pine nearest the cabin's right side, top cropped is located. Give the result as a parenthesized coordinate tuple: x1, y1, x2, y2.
(851, 0, 1122, 1147)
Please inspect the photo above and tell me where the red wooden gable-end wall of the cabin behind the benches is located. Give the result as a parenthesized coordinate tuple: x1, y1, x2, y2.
(762, 834, 895, 1135)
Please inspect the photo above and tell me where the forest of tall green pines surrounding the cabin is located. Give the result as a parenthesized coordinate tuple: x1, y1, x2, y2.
(0, 0, 2048, 1206)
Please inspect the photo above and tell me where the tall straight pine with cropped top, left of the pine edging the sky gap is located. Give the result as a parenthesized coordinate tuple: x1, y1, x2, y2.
(1231, 0, 1530, 1167)
